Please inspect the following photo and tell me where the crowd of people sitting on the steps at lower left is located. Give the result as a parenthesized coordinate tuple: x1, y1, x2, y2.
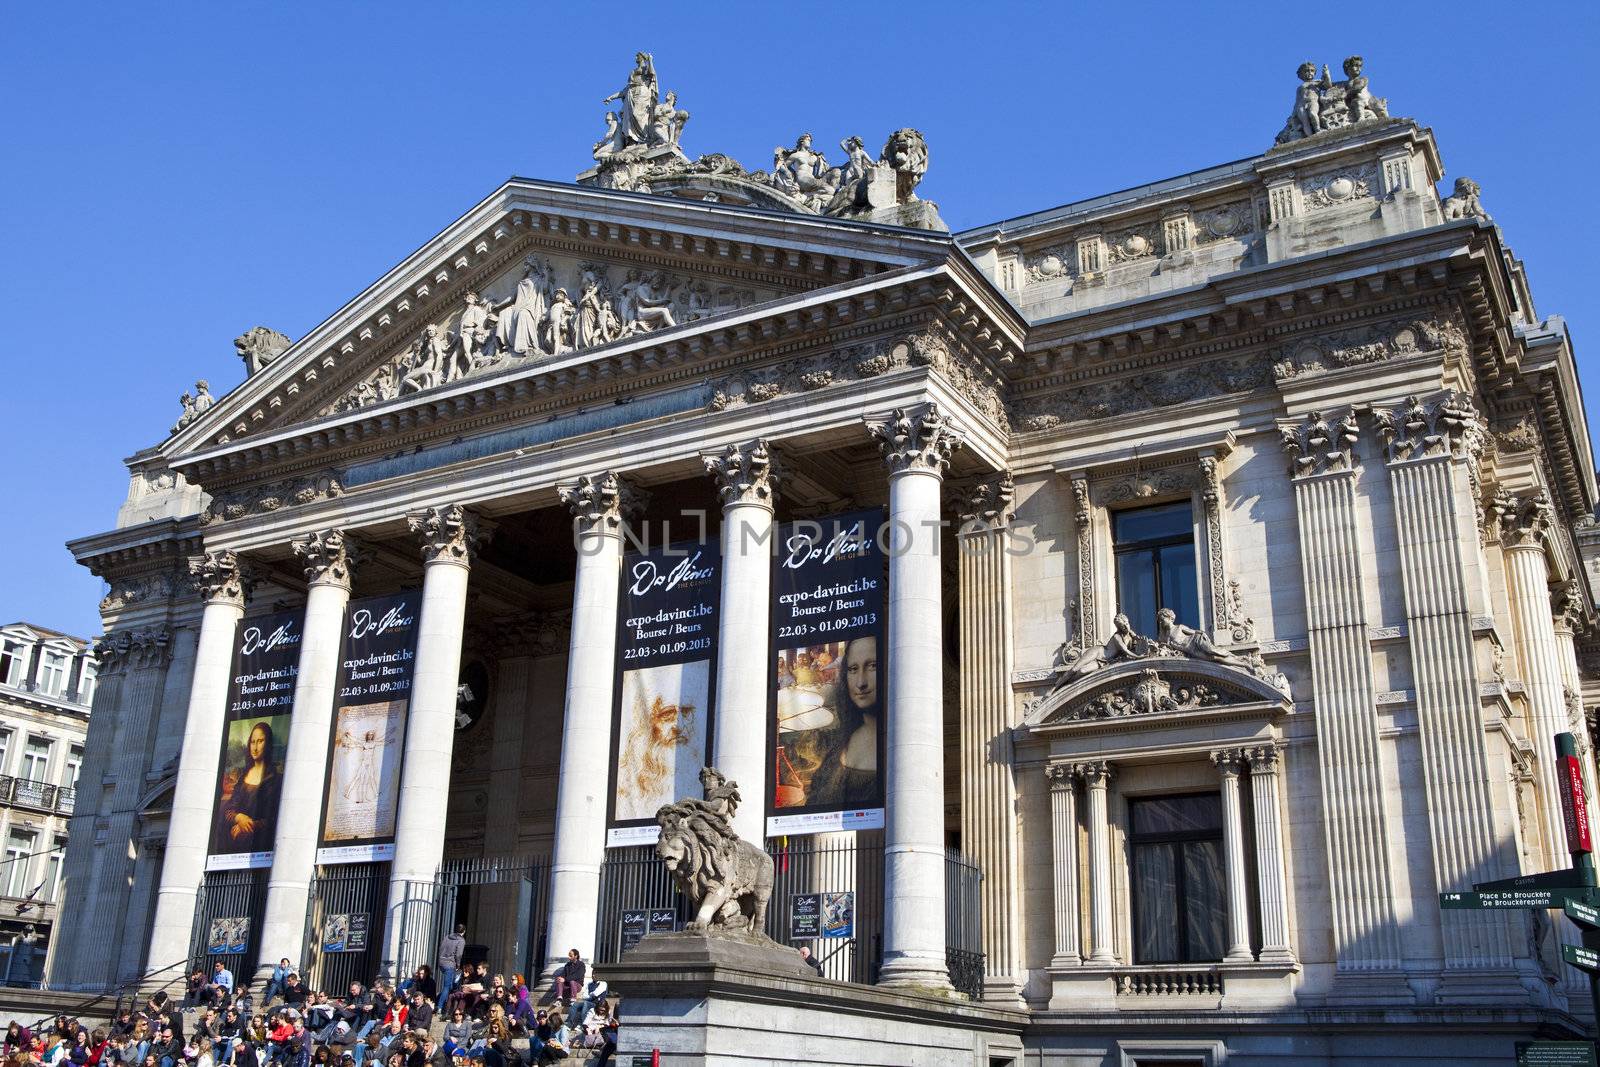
(0, 926, 618, 1067)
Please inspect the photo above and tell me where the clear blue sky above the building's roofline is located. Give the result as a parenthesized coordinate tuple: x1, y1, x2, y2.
(0, 0, 1600, 635)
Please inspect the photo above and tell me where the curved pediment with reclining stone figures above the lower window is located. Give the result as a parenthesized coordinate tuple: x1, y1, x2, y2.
(1024, 608, 1290, 726)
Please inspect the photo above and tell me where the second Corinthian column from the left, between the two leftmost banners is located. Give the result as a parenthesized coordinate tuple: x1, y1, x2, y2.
(256, 530, 352, 981)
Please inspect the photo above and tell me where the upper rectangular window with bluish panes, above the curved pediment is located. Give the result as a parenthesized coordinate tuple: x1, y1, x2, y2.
(1110, 501, 1200, 635)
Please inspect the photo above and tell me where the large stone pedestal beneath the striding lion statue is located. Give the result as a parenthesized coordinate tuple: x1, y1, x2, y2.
(598, 933, 1027, 1067)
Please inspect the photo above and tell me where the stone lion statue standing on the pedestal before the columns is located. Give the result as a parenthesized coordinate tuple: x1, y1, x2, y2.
(656, 768, 773, 936)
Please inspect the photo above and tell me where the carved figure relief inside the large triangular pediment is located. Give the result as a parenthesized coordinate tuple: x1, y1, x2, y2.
(323, 254, 778, 414)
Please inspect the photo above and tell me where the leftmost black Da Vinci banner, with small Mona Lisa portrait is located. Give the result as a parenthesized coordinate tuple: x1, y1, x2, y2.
(205, 611, 301, 870)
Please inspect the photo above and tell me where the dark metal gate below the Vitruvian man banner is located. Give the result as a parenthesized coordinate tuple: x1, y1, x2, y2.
(301, 862, 389, 993)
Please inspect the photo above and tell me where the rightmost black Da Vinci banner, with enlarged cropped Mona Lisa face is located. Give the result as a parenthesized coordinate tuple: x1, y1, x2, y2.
(766, 510, 888, 837)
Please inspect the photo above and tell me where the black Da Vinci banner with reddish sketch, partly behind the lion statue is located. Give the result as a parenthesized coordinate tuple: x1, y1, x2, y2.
(606, 542, 722, 848)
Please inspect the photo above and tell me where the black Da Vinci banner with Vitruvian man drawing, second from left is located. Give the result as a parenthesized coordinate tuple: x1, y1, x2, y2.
(317, 592, 421, 864)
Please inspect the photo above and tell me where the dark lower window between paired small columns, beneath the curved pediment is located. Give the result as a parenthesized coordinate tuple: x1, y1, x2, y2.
(1128, 793, 1227, 963)
